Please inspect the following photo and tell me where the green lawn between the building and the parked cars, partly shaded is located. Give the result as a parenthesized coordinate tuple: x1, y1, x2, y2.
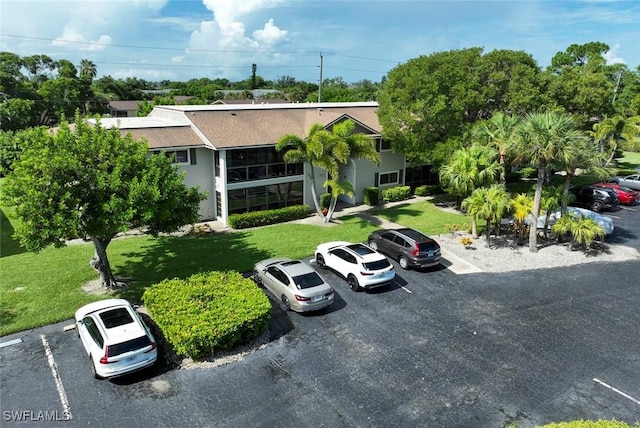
(0, 203, 466, 335)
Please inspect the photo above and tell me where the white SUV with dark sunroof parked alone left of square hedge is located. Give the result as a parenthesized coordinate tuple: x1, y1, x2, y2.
(75, 299, 158, 379)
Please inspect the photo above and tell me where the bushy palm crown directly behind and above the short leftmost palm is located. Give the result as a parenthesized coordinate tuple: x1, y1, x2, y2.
(439, 144, 500, 205)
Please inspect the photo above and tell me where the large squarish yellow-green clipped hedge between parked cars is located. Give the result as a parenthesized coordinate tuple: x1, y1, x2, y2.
(142, 271, 271, 359)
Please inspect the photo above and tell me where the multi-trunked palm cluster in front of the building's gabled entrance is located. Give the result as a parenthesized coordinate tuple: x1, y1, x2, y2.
(276, 120, 380, 222)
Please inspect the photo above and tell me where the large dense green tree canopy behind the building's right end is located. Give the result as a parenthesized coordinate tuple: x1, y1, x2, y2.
(377, 48, 546, 166)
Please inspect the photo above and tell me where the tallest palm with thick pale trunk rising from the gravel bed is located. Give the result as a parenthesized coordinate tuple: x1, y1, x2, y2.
(514, 112, 582, 252)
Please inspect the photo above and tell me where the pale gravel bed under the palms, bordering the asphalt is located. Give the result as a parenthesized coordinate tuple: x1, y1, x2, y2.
(434, 233, 640, 272)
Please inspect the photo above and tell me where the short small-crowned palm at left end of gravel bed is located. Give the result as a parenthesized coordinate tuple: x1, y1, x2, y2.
(462, 183, 511, 247)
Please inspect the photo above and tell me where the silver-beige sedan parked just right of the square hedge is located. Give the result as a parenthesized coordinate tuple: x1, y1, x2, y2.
(253, 257, 335, 312)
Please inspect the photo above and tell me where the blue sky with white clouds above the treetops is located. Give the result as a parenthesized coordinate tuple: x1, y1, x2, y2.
(0, 0, 640, 82)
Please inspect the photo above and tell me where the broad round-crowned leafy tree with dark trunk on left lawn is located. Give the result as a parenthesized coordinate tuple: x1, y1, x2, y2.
(3, 114, 206, 287)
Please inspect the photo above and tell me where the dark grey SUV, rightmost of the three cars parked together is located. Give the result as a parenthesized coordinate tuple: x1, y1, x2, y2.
(368, 228, 442, 269)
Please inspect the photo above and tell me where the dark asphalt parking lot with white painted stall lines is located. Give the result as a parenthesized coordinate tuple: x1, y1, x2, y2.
(0, 207, 640, 427)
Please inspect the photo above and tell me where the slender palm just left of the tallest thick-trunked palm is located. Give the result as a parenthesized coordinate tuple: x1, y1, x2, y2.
(473, 112, 520, 184)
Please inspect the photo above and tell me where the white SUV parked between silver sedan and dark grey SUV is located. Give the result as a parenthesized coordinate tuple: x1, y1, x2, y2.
(316, 241, 396, 291)
